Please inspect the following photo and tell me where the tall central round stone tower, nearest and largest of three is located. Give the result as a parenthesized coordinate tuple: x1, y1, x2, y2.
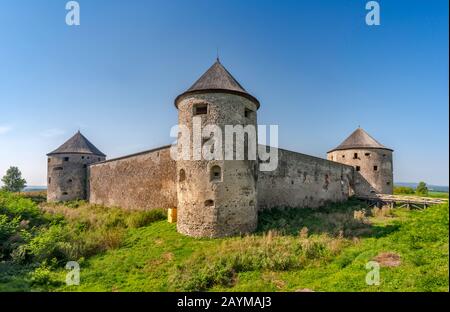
(175, 60, 259, 237)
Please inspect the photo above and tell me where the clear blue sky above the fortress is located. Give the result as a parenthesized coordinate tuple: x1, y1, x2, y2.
(0, 0, 449, 185)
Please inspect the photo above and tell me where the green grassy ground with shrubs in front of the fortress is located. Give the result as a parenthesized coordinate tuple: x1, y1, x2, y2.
(0, 193, 449, 291)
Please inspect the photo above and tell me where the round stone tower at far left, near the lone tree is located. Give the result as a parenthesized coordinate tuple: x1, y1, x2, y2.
(47, 131, 106, 201)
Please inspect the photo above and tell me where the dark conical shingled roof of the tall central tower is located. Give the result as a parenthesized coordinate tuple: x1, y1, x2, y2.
(175, 59, 259, 108)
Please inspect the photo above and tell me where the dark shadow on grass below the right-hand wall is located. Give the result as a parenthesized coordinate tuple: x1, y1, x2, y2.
(257, 198, 399, 237)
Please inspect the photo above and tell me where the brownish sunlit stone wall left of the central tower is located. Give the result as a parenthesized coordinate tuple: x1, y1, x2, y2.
(88, 146, 177, 210)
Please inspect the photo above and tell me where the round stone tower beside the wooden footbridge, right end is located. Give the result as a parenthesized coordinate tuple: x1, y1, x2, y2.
(327, 128, 394, 196)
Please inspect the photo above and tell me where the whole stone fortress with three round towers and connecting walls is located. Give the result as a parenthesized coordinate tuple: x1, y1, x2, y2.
(47, 60, 393, 237)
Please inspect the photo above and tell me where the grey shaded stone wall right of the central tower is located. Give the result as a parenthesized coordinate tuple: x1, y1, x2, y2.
(258, 149, 353, 210)
